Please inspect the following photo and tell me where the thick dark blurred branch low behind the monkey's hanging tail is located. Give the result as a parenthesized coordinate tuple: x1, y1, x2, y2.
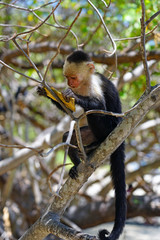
(65, 195, 160, 229)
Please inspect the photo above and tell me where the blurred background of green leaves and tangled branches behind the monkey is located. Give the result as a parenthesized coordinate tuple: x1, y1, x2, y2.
(0, 0, 160, 239)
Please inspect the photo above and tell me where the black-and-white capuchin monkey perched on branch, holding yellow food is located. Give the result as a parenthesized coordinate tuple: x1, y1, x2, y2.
(37, 50, 126, 240)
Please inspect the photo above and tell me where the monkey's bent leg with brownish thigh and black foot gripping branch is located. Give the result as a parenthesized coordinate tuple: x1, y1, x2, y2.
(63, 126, 96, 179)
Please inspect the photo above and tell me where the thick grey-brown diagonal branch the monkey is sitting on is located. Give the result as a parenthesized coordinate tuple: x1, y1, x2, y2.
(21, 85, 160, 240)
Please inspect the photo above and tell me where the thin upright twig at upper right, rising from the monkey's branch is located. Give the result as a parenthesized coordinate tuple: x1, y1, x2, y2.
(140, 0, 151, 92)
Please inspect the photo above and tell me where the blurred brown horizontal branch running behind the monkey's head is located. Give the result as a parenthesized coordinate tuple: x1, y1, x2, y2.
(2, 42, 160, 65)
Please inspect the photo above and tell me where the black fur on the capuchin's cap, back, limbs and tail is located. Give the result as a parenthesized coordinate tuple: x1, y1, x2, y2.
(37, 51, 126, 240)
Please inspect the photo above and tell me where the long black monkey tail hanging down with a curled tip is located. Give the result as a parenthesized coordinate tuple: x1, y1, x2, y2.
(98, 143, 126, 240)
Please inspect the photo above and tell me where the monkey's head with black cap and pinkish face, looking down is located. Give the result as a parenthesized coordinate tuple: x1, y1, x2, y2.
(63, 50, 95, 88)
